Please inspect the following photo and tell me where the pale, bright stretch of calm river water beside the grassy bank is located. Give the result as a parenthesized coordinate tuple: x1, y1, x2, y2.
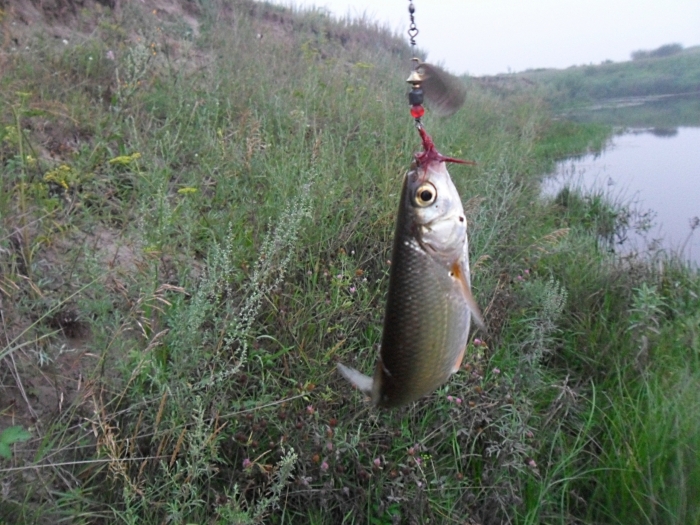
(544, 127, 700, 266)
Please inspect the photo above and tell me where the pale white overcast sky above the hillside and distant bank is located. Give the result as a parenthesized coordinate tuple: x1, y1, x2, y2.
(264, 0, 700, 75)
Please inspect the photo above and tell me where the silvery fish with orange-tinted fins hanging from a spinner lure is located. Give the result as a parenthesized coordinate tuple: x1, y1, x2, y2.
(337, 124, 486, 408)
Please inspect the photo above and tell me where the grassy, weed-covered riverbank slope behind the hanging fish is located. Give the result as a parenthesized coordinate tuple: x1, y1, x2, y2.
(0, 1, 700, 524)
